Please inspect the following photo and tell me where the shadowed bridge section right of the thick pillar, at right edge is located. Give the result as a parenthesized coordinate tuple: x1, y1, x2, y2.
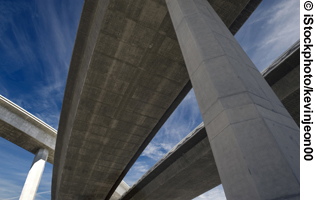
(262, 40, 300, 126)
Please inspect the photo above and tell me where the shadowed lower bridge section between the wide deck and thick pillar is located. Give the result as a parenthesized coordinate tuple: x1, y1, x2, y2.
(121, 124, 221, 200)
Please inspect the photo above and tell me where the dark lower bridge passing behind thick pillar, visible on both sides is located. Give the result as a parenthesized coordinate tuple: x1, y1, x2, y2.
(121, 41, 300, 200)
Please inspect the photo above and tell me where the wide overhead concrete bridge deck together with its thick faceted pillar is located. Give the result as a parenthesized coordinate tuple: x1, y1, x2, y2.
(52, 0, 299, 199)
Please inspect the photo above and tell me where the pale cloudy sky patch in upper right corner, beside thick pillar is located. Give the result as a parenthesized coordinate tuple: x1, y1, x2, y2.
(235, 0, 300, 71)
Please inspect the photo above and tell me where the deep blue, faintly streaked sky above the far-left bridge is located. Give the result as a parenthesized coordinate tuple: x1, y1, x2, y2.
(0, 0, 83, 128)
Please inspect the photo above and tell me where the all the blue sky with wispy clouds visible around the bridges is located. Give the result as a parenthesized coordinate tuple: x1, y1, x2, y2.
(0, 0, 299, 200)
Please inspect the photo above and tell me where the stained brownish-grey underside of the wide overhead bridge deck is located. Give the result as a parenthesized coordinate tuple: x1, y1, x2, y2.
(52, 0, 262, 200)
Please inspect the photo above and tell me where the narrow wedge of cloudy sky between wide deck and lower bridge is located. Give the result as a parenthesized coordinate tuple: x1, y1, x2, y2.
(124, 90, 202, 185)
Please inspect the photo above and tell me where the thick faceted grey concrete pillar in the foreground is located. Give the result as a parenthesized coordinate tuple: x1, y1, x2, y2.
(166, 0, 300, 200)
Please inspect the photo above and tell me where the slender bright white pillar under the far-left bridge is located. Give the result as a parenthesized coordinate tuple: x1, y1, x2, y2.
(20, 149, 48, 200)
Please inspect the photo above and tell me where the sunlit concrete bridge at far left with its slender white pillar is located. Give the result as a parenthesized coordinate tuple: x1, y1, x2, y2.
(0, 95, 129, 200)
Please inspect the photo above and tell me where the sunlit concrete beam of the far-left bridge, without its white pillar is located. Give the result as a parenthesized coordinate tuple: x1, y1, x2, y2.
(0, 95, 57, 163)
